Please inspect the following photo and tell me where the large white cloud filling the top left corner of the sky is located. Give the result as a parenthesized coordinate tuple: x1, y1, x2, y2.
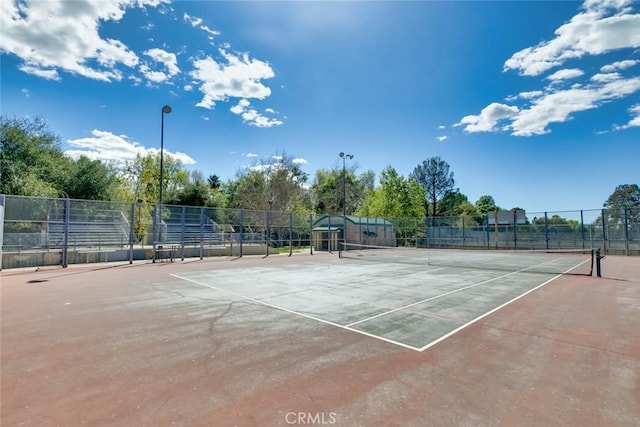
(0, 0, 169, 81)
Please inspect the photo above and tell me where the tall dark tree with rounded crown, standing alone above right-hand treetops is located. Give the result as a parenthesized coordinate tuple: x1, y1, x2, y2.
(411, 157, 455, 216)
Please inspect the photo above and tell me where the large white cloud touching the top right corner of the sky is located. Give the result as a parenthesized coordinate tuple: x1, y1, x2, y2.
(504, 0, 640, 76)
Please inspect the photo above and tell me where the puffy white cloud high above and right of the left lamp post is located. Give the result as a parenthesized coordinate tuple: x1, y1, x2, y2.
(190, 49, 275, 109)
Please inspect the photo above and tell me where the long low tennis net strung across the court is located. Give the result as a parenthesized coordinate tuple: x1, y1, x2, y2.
(339, 242, 601, 276)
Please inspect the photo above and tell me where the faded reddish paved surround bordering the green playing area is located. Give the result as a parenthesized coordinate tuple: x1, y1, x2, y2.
(0, 255, 640, 426)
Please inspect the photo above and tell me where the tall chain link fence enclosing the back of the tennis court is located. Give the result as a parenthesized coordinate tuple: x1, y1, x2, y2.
(0, 195, 640, 268)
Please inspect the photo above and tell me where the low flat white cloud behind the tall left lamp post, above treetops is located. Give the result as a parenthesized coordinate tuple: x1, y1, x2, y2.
(65, 129, 196, 165)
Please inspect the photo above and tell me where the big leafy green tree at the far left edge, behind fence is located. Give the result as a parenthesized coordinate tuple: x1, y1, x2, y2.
(0, 116, 71, 197)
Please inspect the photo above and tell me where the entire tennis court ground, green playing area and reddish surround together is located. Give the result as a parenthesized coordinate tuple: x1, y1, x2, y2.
(1, 248, 640, 426)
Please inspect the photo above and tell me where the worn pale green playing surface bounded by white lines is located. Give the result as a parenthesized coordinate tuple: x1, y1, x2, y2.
(174, 254, 571, 351)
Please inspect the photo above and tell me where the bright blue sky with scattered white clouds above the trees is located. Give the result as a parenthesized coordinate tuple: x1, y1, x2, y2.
(0, 0, 640, 212)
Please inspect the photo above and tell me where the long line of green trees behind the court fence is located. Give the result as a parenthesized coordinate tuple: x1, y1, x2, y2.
(0, 116, 640, 224)
